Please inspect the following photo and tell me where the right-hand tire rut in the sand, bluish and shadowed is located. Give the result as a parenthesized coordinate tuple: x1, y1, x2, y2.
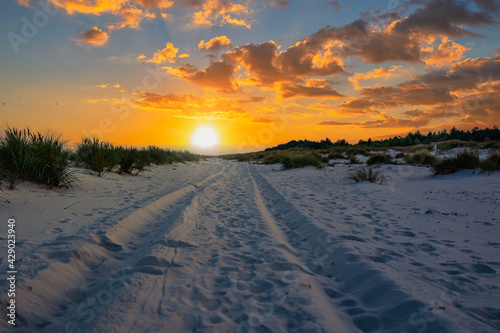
(249, 165, 457, 333)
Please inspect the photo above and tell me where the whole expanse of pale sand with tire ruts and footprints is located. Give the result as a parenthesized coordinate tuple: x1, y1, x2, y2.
(0, 160, 500, 333)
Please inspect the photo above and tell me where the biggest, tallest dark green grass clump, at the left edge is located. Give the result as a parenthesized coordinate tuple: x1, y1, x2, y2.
(0, 128, 75, 189)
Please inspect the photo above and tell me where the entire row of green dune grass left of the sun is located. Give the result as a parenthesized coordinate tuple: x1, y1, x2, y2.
(0, 128, 201, 189)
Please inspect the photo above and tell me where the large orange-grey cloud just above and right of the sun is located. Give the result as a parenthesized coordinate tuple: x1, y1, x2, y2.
(167, 38, 344, 94)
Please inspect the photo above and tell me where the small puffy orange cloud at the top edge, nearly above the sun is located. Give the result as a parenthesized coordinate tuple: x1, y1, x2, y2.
(193, 0, 251, 29)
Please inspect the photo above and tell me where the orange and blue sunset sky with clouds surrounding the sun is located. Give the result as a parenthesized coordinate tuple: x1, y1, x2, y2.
(0, 0, 500, 152)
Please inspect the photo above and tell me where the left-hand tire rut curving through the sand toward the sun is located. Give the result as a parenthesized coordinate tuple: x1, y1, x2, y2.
(0, 160, 227, 332)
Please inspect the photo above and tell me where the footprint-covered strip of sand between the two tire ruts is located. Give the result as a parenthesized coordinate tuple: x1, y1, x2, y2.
(89, 164, 354, 332)
